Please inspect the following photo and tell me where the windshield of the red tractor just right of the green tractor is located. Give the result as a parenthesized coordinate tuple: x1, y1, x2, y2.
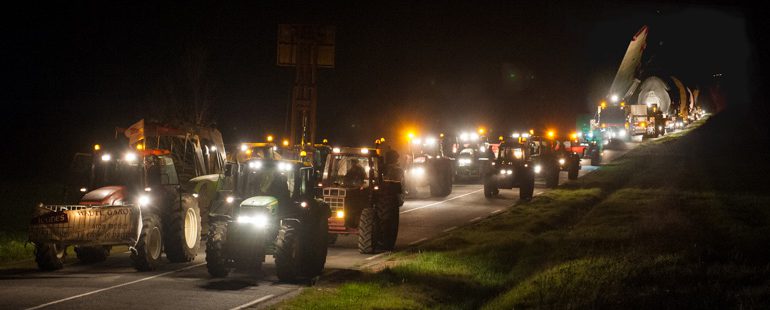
(323, 155, 371, 187)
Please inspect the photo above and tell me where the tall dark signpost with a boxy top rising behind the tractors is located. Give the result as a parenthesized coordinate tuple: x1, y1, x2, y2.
(277, 24, 334, 147)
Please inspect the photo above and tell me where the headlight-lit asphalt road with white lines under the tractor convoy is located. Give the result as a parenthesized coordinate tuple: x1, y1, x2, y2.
(0, 143, 637, 309)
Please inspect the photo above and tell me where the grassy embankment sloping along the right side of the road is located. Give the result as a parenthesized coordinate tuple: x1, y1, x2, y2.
(276, 115, 770, 309)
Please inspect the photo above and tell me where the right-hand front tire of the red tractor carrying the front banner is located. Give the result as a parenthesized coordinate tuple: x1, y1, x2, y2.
(131, 214, 163, 271)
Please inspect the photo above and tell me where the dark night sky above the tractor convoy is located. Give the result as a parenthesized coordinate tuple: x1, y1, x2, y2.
(0, 1, 754, 180)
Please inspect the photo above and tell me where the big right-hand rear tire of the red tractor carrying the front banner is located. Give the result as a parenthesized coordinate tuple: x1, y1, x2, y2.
(164, 194, 201, 263)
